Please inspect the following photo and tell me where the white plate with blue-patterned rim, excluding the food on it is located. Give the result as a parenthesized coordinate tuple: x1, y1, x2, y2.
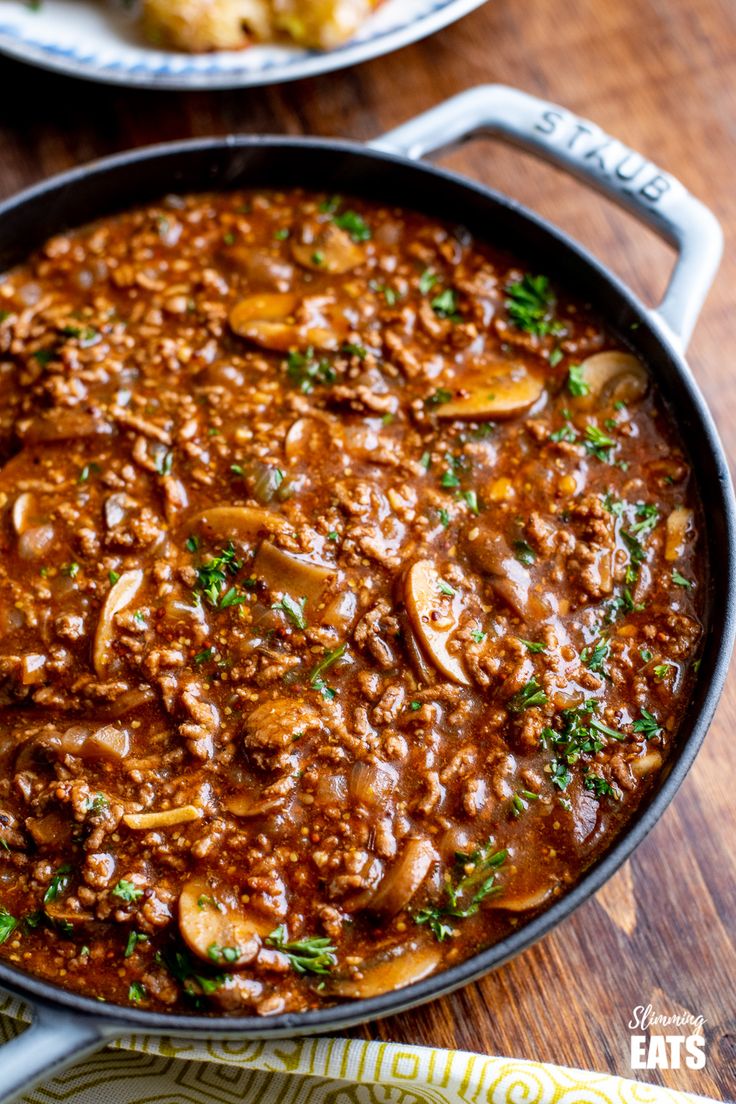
(0, 0, 484, 89)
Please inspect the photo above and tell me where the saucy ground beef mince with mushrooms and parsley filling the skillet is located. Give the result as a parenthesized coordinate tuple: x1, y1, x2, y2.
(0, 191, 705, 1015)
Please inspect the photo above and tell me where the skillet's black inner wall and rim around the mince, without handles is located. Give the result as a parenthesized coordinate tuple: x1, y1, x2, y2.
(0, 138, 736, 1039)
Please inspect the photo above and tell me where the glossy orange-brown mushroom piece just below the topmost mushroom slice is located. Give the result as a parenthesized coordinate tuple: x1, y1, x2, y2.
(230, 291, 348, 352)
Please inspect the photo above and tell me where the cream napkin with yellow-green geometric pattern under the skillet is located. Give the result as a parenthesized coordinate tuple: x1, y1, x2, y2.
(0, 997, 705, 1104)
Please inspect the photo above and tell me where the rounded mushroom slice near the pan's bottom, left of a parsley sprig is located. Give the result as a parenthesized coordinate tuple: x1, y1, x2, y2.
(179, 878, 273, 967)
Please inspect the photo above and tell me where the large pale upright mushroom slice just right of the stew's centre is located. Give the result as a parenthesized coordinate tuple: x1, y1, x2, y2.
(405, 560, 470, 686)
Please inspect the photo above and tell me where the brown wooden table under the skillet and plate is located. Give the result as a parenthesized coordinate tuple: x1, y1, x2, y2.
(0, 0, 736, 1098)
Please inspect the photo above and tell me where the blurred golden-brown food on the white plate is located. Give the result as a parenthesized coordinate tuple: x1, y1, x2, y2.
(140, 0, 380, 53)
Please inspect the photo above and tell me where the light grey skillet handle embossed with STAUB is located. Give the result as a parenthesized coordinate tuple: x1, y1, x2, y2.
(371, 84, 723, 349)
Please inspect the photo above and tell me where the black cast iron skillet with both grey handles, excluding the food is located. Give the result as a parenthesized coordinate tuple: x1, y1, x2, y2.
(0, 86, 736, 1104)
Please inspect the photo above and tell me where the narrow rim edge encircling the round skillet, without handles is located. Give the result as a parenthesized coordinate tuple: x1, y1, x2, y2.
(0, 135, 736, 1041)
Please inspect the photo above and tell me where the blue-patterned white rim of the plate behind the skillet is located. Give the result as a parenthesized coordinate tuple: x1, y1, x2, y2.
(0, 0, 486, 88)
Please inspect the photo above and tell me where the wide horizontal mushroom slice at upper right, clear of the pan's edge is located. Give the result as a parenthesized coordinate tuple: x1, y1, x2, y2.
(435, 363, 544, 422)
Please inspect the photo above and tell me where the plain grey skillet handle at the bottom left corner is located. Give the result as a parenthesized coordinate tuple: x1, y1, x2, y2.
(0, 1006, 109, 1104)
